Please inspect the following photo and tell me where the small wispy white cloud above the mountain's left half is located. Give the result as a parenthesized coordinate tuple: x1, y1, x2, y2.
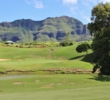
(25, 0, 44, 9)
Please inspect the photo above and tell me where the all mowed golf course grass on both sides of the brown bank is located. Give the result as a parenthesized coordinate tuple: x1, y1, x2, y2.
(0, 44, 106, 100)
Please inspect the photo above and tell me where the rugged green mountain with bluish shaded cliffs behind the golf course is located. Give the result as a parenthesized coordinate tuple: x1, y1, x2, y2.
(0, 16, 89, 42)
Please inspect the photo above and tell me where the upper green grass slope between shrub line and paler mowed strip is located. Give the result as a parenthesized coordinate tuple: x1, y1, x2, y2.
(0, 44, 88, 59)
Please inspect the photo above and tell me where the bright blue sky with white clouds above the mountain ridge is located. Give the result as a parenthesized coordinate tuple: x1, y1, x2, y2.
(0, 0, 110, 24)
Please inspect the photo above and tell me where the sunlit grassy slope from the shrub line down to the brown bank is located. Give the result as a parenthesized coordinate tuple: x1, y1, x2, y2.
(0, 45, 92, 71)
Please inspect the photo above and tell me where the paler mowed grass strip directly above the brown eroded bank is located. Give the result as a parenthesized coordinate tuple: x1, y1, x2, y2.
(0, 59, 93, 71)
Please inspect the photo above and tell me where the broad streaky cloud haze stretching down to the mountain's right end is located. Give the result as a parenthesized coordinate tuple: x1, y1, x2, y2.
(62, 0, 91, 23)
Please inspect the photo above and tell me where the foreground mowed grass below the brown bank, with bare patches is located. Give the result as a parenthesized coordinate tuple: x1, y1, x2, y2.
(0, 74, 110, 100)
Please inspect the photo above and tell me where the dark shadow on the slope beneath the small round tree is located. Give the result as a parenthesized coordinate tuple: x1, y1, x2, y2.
(69, 53, 93, 63)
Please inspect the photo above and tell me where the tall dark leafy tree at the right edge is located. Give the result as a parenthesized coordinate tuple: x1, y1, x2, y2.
(88, 3, 110, 75)
